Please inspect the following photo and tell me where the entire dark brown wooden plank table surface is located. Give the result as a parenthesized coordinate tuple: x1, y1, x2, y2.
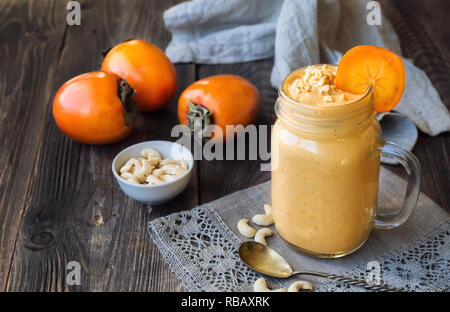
(0, 0, 450, 291)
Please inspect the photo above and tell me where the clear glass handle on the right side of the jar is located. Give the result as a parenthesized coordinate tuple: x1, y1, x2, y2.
(374, 142, 422, 230)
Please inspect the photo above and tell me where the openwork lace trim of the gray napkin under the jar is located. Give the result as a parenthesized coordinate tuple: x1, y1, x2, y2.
(148, 204, 450, 292)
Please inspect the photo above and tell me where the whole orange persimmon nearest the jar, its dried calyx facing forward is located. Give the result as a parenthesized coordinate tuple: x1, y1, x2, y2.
(178, 75, 261, 142)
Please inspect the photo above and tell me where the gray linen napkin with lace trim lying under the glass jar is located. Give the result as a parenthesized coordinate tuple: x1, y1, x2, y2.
(148, 168, 450, 291)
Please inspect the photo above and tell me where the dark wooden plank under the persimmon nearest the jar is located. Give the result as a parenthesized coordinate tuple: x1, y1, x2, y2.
(197, 60, 277, 203)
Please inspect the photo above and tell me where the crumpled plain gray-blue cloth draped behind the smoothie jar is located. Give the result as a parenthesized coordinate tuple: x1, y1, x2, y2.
(164, 0, 450, 143)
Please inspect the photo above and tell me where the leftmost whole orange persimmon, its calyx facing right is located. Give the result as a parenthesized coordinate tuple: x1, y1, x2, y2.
(53, 71, 137, 144)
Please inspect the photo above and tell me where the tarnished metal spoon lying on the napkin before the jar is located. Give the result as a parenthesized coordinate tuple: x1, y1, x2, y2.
(239, 241, 399, 292)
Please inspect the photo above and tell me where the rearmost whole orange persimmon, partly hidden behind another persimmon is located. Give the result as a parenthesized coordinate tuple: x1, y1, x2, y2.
(101, 40, 177, 111)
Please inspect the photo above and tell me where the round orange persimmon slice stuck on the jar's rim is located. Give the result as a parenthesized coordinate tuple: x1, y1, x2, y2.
(336, 45, 405, 113)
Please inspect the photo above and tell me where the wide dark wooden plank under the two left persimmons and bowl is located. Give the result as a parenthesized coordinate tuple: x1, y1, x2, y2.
(7, 1, 198, 291)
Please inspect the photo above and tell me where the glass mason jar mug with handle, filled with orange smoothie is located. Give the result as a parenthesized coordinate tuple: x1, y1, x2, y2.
(272, 65, 421, 258)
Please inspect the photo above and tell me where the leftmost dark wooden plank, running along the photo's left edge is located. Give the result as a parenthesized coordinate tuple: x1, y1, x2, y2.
(0, 0, 65, 290)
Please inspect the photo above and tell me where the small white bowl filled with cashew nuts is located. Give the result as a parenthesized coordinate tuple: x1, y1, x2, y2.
(112, 141, 194, 205)
